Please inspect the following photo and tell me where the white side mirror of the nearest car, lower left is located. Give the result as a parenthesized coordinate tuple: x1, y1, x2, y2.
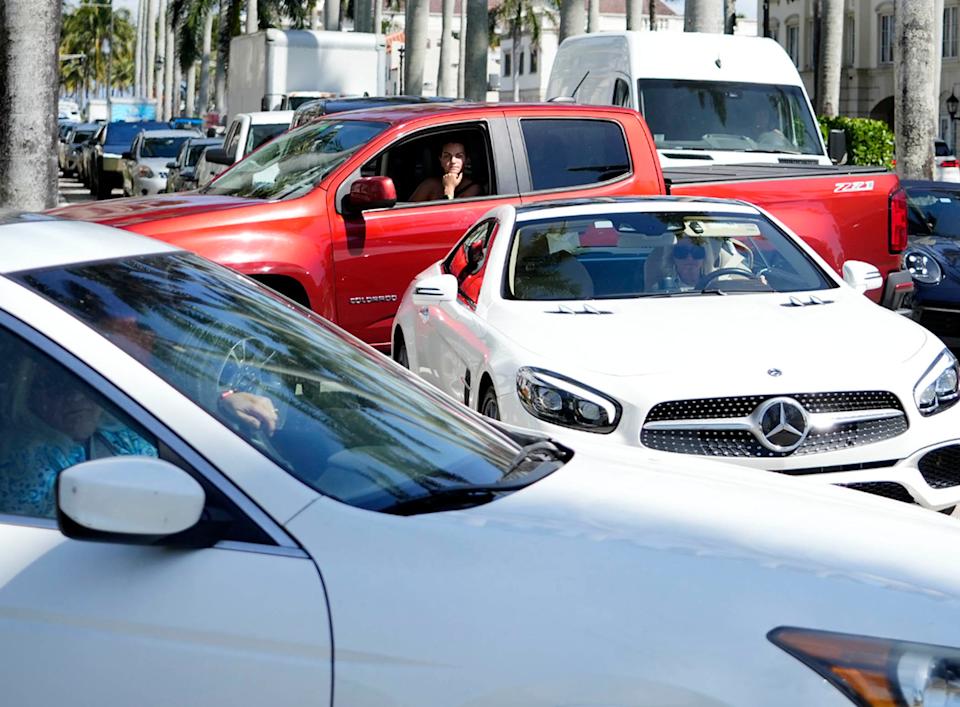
(56, 456, 206, 543)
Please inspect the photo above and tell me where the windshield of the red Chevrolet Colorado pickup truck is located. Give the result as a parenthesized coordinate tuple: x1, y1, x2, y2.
(201, 120, 387, 199)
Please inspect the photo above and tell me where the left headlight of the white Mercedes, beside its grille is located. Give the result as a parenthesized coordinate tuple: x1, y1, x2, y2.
(517, 366, 621, 434)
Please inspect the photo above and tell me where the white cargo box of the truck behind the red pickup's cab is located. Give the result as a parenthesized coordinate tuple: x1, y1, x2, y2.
(227, 29, 387, 114)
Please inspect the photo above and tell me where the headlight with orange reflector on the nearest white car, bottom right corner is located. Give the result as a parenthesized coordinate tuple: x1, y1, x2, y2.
(767, 626, 960, 707)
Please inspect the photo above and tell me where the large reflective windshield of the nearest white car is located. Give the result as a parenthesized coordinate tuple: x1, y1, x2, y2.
(17, 253, 532, 511)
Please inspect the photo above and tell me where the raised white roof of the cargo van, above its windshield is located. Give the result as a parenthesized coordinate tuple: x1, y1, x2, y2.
(550, 31, 801, 86)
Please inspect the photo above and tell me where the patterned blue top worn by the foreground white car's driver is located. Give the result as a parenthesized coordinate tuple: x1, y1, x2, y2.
(0, 418, 157, 518)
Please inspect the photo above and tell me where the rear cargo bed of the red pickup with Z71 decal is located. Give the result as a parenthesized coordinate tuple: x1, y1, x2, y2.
(664, 164, 901, 301)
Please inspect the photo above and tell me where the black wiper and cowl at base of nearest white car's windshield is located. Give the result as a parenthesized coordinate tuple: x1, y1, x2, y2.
(381, 439, 571, 516)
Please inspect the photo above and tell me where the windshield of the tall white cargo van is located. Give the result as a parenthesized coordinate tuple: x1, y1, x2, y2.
(637, 79, 823, 155)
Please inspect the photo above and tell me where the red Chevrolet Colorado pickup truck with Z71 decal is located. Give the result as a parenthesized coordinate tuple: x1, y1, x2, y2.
(53, 104, 911, 350)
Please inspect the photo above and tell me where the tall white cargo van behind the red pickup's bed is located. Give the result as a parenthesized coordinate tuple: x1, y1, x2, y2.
(547, 32, 831, 167)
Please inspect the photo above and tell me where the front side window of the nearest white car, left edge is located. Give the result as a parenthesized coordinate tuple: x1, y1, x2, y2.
(0, 329, 157, 518)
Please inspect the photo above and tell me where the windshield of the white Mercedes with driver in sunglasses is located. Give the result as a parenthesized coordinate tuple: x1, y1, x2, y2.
(506, 212, 836, 300)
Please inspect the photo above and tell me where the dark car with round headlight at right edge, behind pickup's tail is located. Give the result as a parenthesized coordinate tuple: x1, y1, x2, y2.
(903, 180, 960, 350)
